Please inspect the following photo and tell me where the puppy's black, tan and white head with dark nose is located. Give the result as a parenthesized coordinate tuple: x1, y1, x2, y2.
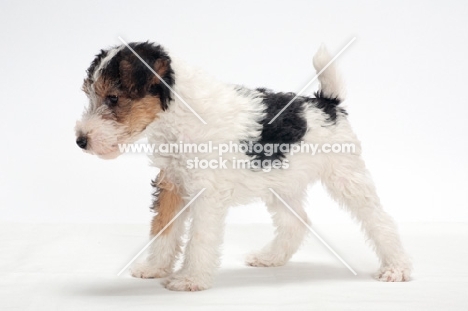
(75, 42, 174, 159)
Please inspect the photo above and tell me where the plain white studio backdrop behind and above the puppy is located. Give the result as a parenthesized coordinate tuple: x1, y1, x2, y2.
(0, 1, 468, 223)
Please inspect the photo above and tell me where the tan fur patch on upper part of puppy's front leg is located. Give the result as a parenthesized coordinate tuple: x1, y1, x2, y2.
(151, 172, 182, 236)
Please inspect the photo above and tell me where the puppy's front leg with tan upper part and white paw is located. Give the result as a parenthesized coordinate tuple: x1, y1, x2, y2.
(131, 171, 187, 278)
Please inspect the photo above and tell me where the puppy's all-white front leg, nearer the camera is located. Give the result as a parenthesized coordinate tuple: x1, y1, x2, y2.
(163, 191, 227, 291)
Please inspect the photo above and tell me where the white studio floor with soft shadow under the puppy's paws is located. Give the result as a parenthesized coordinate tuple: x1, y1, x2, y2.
(0, 223, 468, 311)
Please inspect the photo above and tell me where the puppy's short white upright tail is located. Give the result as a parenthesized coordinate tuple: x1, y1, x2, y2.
(314, 45, 346, 102)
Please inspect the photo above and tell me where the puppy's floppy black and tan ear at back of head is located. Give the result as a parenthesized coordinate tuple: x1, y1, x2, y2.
(148, 58, 174, 110)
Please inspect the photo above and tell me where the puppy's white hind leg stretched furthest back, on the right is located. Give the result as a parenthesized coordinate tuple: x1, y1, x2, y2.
(322, 154, 411, 282)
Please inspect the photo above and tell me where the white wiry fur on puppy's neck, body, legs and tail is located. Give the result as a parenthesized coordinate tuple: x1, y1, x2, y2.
(134, 50, 411, 290)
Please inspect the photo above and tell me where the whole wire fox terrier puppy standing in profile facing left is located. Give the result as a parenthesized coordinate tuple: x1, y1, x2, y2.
(76, 42, 411, 291)
